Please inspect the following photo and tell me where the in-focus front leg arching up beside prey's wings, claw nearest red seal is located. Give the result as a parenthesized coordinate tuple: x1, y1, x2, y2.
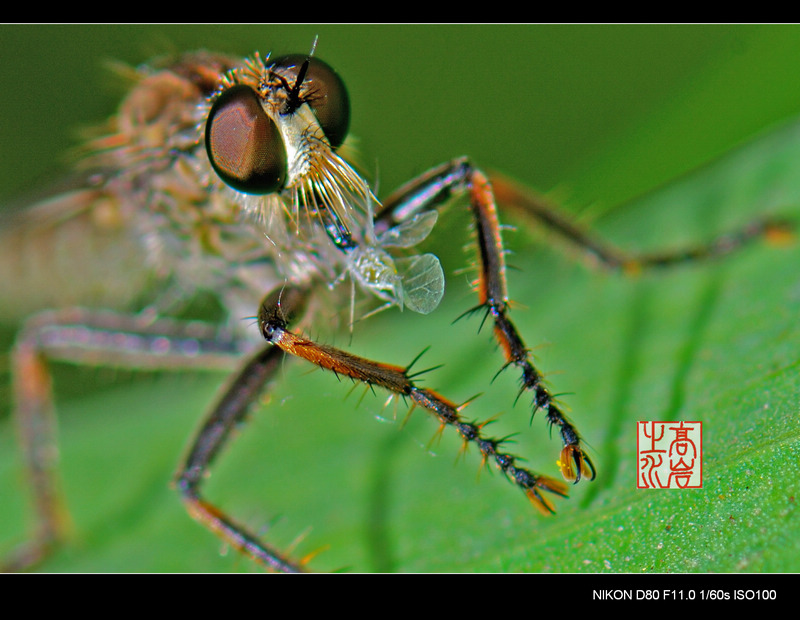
(376, 158, 595, 483)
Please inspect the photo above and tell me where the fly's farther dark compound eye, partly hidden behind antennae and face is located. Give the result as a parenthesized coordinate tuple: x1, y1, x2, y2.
(272, 54, 350, 148)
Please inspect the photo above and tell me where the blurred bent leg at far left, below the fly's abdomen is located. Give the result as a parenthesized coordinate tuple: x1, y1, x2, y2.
(0, 308, 248, 571)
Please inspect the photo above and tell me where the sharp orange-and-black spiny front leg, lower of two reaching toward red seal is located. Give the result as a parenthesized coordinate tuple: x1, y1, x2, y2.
(259, 288, 567, 514)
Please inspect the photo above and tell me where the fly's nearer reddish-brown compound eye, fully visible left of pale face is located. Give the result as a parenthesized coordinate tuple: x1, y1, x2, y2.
(206, 84, 287, 194)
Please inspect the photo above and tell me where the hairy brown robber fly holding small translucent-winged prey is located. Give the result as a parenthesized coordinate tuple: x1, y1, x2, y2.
(0, 40, 780, 572)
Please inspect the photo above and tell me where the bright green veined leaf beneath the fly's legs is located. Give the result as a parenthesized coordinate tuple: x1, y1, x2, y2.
(2, 115, 800, 572)
